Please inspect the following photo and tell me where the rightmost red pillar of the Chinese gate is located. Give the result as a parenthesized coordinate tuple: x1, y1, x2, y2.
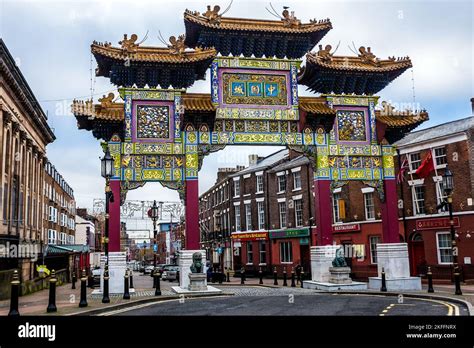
(381, 179, 400, 243)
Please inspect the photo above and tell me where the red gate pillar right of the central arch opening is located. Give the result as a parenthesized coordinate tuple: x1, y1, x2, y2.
(314, 179, 333, 245)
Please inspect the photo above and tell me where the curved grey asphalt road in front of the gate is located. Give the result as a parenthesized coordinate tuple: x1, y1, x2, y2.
(99, 287, 467, 316)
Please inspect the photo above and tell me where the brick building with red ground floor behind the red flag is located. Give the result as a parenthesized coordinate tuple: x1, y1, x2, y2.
(397, 111, 474, 279)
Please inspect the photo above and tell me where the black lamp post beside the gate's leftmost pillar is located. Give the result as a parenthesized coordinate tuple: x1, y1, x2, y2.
(100, 146, 114, 303)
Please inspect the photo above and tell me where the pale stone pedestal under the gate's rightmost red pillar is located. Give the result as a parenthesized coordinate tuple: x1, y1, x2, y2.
(369, 243, 421, 291)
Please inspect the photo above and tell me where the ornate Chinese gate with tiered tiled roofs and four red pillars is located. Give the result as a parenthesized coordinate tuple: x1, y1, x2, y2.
(72, 6, 428, 290)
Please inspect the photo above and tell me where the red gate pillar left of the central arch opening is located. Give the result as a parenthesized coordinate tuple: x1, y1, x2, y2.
(186, 178, 200, 250)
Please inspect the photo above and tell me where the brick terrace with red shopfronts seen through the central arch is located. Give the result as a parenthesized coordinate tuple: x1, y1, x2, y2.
(199, 149, 315, 274)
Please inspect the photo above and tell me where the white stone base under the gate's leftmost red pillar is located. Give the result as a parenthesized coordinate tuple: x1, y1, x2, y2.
(100, 252, 127, 294)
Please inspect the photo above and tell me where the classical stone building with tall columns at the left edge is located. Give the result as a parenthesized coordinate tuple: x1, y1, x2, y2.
(0, 39, 55, 281)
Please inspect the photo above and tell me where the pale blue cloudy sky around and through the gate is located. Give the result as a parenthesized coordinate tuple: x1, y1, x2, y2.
(0, 0, 474, 212)
